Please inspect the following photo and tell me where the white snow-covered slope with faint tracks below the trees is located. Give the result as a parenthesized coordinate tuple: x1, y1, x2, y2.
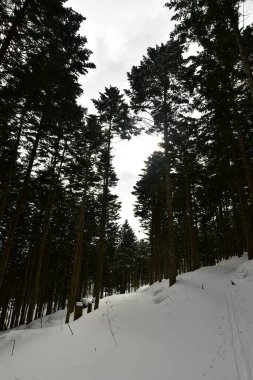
(0, 257, 253, 380)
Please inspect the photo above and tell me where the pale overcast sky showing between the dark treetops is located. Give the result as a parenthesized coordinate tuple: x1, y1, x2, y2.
(67, 0, 253, 237)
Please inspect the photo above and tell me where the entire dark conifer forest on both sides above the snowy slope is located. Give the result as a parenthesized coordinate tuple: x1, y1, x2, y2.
(0, 0, 253, 330)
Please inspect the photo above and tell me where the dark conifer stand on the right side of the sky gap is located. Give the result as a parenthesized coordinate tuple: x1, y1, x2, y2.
(128, 0, 253, 285)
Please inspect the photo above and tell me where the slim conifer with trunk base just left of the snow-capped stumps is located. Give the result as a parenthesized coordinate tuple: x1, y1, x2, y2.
(66, 115, 104, 323)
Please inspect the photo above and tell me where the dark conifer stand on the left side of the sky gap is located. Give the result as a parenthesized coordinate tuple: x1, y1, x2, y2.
(0, 0, 149, 330)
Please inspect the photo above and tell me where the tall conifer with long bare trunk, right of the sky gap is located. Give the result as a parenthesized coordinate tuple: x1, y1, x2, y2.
(128, 40, 186, 285)
